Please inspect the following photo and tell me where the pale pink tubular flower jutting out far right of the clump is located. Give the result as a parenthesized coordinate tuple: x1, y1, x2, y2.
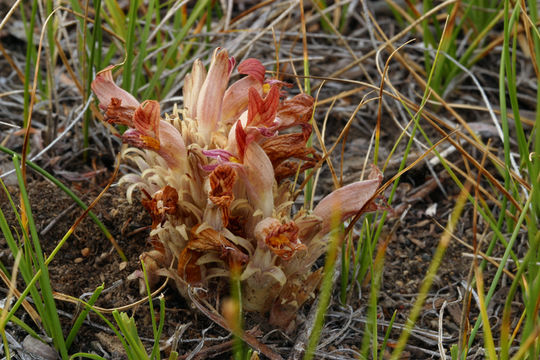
(313, 167, 383, 234)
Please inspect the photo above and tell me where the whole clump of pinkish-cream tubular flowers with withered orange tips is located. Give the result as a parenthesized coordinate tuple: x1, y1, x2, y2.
(92, 49, 382, 328)
